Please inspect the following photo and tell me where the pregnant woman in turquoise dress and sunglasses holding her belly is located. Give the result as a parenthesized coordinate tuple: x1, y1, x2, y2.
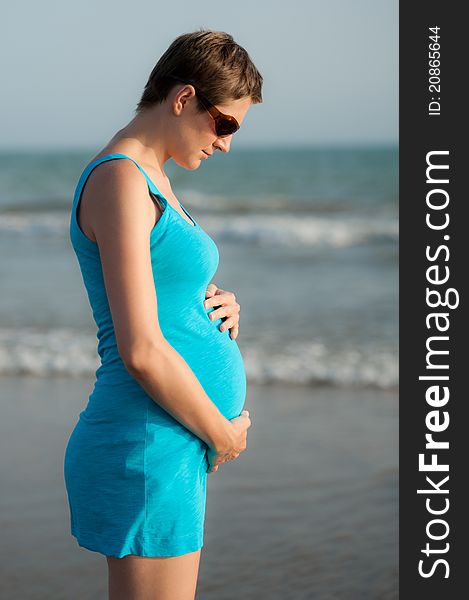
(64, 30, 262, 600)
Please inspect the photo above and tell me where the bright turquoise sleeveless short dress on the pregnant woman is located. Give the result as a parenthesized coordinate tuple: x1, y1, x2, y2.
(64, 154, 246, 558)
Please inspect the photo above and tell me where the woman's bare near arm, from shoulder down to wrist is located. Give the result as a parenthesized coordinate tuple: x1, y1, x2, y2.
(81, 160, 235, 448)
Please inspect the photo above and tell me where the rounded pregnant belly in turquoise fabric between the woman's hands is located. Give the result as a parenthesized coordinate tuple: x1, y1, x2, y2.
(162, 309, 246, 419)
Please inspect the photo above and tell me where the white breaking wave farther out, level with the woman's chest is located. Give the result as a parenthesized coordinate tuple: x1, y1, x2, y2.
(0, 211, 399, 248)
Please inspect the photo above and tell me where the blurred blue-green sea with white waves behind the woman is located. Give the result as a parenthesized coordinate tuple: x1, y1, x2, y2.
(0, 147, 399, 389)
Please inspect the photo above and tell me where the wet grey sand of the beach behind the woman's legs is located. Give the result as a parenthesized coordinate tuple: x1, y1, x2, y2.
(0, 377, 398, 600)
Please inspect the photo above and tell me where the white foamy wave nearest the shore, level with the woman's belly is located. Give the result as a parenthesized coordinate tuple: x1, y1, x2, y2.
(0, 328, 398, 390)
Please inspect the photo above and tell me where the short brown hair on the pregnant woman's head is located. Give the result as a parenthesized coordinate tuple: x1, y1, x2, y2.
(135, 29, 263, 113)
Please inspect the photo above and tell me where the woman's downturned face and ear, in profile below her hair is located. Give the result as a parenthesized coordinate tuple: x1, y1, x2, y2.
(170, 84, 251, 171)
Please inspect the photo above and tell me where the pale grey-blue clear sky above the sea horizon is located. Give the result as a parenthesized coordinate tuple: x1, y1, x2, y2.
(0, 0, 399, 150)
